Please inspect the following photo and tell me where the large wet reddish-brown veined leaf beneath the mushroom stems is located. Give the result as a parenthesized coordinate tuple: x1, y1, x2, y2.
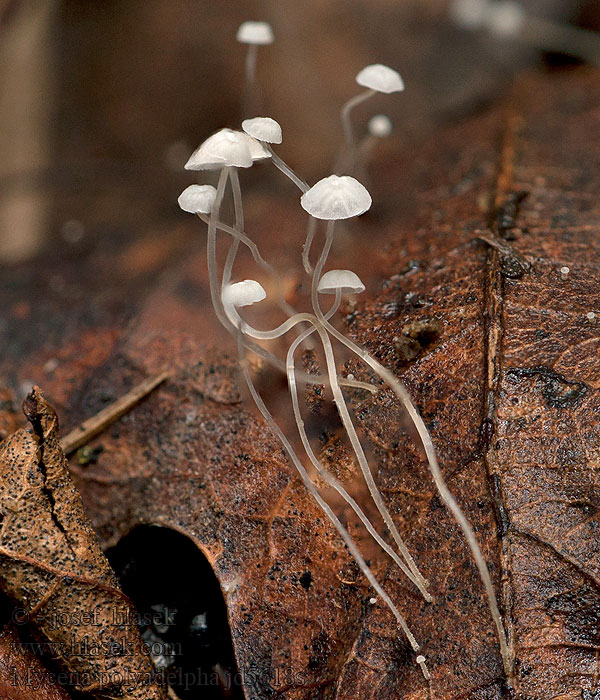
(3, 72, 600, 700)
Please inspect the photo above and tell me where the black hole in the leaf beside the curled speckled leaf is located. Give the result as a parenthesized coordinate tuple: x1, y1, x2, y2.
(106, 526, 243, 700)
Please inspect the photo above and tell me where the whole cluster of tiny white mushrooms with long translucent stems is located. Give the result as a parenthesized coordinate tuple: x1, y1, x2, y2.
(178, 16, 512, 681)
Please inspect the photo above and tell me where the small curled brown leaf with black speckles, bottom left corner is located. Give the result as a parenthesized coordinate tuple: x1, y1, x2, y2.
(0, 388, 166, 700)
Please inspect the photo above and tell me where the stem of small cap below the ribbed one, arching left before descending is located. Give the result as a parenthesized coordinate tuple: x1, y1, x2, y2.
(286, 300, 431, 601)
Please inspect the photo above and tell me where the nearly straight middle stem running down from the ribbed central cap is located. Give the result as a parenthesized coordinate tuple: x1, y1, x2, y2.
(311, 221, 431, 601)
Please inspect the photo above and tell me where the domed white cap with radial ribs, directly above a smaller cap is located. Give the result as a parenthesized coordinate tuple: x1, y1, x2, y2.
(300, 175, 372, 221)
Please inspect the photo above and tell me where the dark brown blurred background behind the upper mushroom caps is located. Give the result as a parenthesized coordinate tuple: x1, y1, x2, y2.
(0, 0, 600, 265)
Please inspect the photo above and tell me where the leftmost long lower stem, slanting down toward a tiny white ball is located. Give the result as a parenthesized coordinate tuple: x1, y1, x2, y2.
(238, 335, 419, 652)
